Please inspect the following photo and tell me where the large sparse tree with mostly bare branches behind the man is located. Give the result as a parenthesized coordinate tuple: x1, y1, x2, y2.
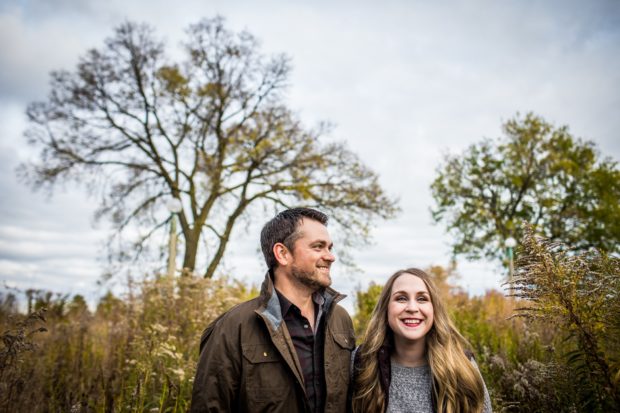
(19, 18, 397, 278)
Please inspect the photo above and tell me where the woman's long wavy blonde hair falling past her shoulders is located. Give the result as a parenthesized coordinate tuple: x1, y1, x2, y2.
(352, 268, 484, 413)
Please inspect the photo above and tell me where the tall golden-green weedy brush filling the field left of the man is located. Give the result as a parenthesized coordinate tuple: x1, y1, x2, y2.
(0, 277, 256, 412)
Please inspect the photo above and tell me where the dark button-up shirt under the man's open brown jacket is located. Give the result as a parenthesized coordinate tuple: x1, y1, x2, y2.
(276, 290, 325, 413)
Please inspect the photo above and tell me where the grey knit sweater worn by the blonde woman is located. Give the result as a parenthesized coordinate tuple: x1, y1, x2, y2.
(387, 360, 492, 413)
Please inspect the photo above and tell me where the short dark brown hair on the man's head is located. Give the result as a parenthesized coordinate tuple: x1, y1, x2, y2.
(260, 208, 329, 270)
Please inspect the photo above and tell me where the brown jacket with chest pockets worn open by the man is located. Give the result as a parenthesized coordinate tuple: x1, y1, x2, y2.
(190, 273, 355, 413)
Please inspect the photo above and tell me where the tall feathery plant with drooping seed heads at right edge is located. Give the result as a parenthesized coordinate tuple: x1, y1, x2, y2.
(513, 226, 620, 412)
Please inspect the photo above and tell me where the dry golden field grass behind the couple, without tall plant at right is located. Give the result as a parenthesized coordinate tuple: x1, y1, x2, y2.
(0, 249, 620, 412)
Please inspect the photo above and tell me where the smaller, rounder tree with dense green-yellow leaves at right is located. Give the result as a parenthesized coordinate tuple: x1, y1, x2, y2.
(431, 113, 620, 259)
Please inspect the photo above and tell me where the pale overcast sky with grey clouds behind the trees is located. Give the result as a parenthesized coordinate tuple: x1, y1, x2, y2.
(0, 0, 620, 309)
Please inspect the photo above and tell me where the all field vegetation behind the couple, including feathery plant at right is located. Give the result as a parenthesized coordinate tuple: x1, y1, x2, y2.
(0, 229, 620, 412)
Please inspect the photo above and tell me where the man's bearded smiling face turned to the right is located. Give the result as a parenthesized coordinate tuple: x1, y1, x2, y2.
(291, 218, 336, 290)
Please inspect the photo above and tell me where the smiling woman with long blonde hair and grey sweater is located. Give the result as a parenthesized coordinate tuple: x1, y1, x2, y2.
(351, 268, 491, 413)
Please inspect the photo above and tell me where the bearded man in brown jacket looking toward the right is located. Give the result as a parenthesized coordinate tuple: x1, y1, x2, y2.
(191, 208, 355, 413)
